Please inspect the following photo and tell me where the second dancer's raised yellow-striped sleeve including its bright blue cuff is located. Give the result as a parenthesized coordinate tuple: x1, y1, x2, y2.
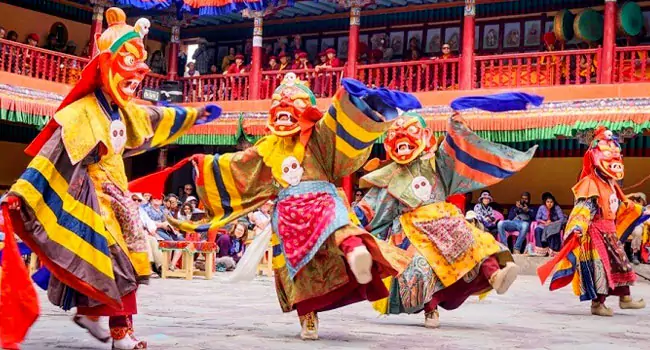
(310, 79, 421, 181)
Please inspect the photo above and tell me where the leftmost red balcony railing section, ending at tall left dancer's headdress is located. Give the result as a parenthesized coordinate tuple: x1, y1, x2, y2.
(0, 39, 88, 84)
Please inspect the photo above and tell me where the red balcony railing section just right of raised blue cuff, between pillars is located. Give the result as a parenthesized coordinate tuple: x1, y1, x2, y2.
(357, 58, 459, 92)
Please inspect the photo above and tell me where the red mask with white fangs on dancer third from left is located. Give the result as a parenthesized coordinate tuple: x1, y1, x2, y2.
(384, 112, 433, 164)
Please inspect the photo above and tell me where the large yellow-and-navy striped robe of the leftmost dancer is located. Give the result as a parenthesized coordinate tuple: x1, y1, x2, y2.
(10, 91, 198, 309)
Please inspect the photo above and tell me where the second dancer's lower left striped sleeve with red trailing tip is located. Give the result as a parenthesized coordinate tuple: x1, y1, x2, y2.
(179, 147, 276, 232)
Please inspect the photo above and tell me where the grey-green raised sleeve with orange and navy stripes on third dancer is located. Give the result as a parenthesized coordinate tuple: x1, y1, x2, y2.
(436, 120, 537, 196)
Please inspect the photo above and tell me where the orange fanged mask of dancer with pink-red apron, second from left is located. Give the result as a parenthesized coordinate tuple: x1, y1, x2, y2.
(267, 73, 321, 137)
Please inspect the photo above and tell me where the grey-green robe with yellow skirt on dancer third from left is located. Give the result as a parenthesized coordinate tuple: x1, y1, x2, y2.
(357, 121, 535, 313)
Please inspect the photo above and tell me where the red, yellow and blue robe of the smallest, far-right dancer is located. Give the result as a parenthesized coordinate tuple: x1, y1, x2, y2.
(537, 173, 646, 301)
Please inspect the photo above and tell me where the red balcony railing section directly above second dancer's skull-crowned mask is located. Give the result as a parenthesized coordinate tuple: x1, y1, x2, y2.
(260, 68, 343, 99)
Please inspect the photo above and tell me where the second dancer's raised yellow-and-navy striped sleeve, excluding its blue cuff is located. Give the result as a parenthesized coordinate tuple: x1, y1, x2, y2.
(310, 87, 392, 180)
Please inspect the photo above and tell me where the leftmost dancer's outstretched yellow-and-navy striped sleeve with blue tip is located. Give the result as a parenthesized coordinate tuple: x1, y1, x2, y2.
(124, 104, 221, 157)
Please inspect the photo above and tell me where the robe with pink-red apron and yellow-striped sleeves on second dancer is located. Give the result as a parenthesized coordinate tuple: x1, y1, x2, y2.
(181, 87, 404, 312)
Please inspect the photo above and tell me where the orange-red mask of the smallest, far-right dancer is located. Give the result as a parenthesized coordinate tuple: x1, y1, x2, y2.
(585, 126, 624, 180)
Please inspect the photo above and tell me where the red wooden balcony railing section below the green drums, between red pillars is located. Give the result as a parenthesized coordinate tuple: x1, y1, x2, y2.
(473, 49, 601, 88)
